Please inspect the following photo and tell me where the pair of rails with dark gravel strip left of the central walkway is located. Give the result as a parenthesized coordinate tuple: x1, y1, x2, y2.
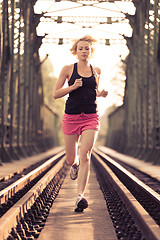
(0, 151, 68, 240)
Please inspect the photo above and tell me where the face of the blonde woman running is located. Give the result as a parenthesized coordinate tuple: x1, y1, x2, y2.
(77, 41, 92, 61)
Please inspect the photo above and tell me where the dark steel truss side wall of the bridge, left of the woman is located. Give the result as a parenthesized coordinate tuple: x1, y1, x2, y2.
(0, 0, 57, 162)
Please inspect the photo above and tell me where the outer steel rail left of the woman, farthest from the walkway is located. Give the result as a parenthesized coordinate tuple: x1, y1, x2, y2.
(0, 150, 65, 204)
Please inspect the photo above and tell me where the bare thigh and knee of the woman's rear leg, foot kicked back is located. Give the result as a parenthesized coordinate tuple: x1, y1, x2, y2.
(64, 134, 79, 166)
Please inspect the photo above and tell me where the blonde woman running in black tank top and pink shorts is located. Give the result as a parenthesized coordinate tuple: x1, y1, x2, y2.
(53, 35, 108, 212)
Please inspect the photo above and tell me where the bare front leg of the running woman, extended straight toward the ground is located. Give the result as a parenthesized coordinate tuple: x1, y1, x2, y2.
(77, 129, 98, 195)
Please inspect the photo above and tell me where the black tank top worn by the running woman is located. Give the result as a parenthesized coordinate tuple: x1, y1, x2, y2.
(65, 63, 97, 114)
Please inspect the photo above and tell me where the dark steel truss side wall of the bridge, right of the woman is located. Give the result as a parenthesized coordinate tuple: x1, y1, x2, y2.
(107, 0, 160, 163)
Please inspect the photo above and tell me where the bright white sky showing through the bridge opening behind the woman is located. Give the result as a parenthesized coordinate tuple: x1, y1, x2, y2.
(34, 0, 135, 116)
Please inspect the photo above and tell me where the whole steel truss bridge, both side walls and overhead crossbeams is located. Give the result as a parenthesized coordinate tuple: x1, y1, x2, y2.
(0, 0, 160, 163)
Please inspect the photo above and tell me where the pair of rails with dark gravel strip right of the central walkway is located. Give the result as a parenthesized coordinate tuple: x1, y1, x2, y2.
(92, 149, 160, 240)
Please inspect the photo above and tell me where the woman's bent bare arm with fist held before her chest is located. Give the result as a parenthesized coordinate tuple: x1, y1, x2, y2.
(53, 65, 82, 99)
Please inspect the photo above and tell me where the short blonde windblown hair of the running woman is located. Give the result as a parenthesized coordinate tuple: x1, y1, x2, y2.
(70, 35, 97, 55)
